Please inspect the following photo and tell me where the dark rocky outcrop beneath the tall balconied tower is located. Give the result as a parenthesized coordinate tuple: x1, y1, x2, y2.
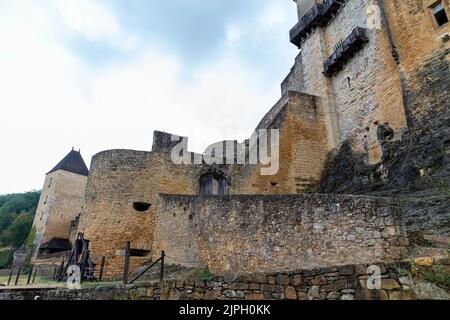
(320, 115, 450, 194)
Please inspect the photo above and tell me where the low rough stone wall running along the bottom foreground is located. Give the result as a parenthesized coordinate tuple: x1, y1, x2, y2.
(6, 261, 448, 301)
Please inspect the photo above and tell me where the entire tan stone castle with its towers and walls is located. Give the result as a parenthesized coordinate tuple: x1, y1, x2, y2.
(34, 0, 450, 277)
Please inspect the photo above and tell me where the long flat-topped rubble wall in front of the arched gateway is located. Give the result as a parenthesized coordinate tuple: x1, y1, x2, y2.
(155, 194, 407, 273)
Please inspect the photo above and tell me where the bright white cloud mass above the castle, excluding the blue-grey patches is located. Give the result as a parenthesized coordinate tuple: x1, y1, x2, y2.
(0, 0, 298, 194)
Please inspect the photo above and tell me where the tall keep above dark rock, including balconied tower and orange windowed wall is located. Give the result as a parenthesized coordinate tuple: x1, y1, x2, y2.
(282, 0, 450, 164)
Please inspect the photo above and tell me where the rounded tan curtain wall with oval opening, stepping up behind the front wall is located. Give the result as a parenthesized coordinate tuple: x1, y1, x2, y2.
(78, 91, 328, 276)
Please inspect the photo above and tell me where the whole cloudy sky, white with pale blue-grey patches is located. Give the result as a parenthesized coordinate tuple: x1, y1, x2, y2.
(0, 0, 297, 194)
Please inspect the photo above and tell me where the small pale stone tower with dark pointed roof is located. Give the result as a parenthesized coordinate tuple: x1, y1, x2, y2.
(33, 149, 89, 258)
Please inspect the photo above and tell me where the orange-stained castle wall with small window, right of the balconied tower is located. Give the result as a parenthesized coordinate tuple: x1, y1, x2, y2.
(384, 0, 450, 127)
